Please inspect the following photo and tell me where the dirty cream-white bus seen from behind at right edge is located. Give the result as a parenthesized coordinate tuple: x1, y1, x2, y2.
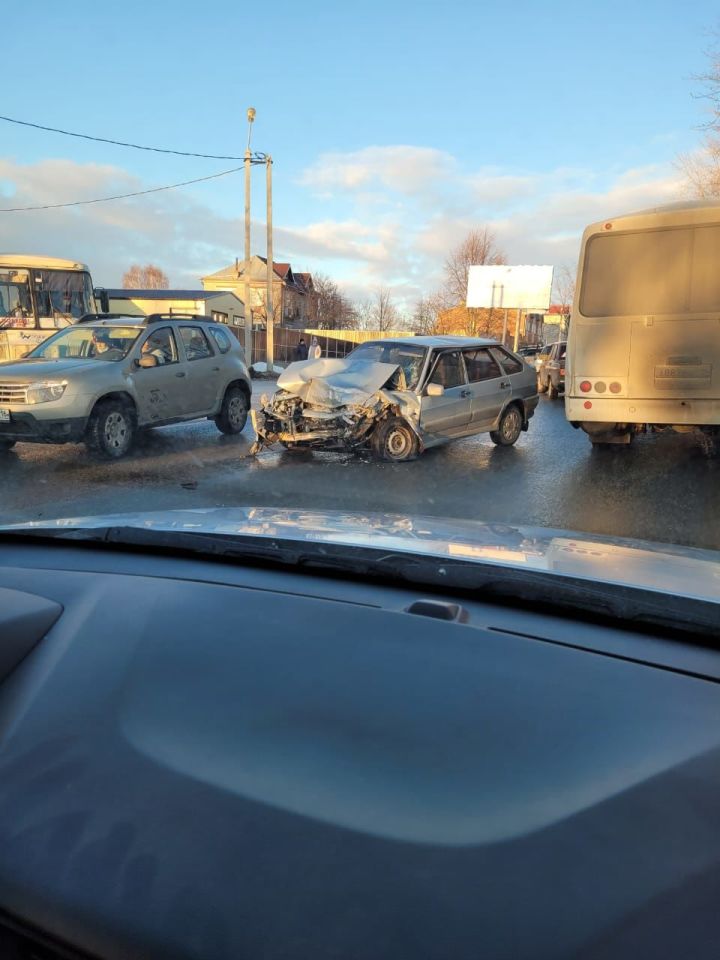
(565, 203, 720, 444)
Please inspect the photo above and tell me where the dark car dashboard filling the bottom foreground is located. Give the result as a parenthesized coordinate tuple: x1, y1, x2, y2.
(0, 543, 720, 960)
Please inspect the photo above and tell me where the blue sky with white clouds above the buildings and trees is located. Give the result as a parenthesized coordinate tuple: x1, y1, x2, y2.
(0, 0, 720, 302)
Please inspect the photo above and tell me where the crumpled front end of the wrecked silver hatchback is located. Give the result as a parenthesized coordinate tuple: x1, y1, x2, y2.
(251, 360, 416, 453)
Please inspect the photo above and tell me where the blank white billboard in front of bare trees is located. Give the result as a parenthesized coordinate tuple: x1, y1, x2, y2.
(466, 264, 553, 312)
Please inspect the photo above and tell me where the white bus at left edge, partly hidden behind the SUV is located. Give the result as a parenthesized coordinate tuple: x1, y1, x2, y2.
(0, 253, 97, 362)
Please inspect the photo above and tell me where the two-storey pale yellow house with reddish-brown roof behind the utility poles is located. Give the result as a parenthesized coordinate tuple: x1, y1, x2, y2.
(201, 256, 314, 329)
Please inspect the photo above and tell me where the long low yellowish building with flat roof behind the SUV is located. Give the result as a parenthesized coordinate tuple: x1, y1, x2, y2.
(107, 289, 245, 327)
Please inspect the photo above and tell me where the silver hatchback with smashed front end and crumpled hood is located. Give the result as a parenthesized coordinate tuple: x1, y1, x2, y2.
(252, 337, 538, 461)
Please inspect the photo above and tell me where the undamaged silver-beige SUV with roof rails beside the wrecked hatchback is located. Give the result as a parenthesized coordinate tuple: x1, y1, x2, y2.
(0, 314, 252, 459)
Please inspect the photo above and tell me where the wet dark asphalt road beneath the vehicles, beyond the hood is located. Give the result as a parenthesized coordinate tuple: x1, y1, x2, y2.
(0, 389, 720, 549)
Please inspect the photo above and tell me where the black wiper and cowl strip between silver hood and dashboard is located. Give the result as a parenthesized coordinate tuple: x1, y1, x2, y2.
(0, 525, 720, 646)
